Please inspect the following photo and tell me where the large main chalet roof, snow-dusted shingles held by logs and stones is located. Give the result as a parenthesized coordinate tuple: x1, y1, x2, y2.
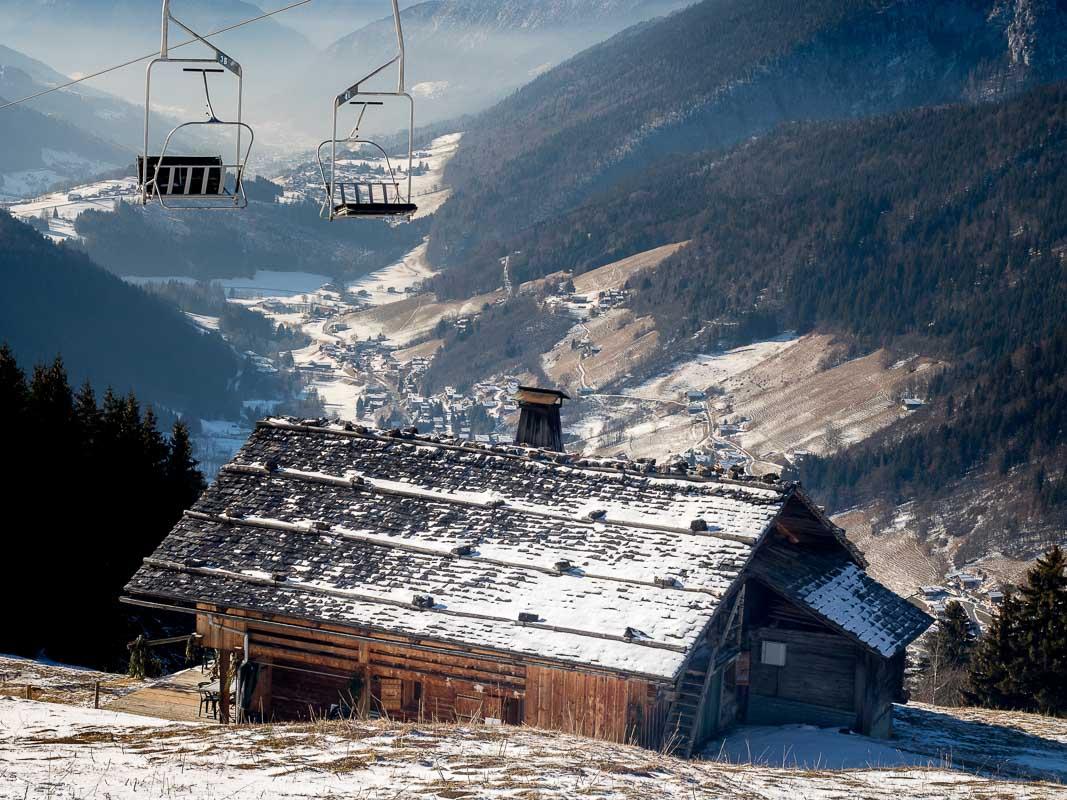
(127, 420, 790, 678)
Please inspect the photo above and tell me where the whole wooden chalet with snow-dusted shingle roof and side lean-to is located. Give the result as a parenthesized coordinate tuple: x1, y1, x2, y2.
(124, 409, 930, 754)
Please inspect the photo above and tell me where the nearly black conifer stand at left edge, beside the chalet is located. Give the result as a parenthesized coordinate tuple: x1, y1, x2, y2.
(0, 345, 205, 669)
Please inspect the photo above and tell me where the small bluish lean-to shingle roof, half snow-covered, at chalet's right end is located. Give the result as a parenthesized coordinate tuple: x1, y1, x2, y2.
(749, 544, 933, 658)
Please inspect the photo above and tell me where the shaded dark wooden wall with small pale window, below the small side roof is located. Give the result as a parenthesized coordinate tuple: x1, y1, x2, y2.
(746, 628, 863, 727)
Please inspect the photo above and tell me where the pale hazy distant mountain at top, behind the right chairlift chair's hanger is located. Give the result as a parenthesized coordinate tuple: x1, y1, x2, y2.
(280, 0, 686, 137)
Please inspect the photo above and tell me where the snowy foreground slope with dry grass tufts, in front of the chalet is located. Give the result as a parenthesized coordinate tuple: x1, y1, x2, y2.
(0, 699, 1064, 800)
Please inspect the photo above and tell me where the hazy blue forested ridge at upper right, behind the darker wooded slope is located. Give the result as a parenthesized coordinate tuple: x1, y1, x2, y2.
(431, 0, 1067, 273)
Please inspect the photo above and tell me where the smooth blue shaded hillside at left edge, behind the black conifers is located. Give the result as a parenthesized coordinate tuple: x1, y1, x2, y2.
(0, 212, 240, 418)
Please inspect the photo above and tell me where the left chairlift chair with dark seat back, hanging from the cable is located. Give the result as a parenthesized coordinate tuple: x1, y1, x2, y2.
(137, 0, 255, 210)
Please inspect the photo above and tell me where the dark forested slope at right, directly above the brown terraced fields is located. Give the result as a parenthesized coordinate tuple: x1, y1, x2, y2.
(439, 83, 1067, 558)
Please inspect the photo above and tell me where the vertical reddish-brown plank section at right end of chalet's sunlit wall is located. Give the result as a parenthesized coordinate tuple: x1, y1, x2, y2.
(526, 667, 666, 748)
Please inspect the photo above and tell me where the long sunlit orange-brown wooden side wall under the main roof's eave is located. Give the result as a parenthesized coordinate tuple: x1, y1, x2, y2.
(197, 609, 666, 748)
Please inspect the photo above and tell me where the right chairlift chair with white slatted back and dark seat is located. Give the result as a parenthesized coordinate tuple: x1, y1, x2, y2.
(317, 0, 418, 222)
